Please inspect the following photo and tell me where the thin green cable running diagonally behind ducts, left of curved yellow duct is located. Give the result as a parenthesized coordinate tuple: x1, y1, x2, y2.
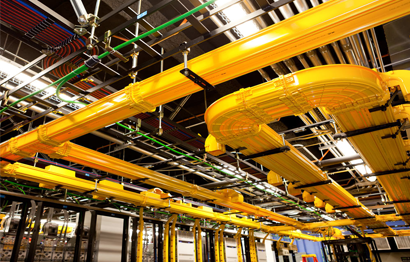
(116, 122, 321, 217)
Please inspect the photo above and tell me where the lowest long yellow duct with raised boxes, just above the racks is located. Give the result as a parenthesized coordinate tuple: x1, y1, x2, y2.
(0, 163, 319, 237)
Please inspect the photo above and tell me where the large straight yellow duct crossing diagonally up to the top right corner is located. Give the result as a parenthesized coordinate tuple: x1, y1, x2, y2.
(0, 0, 410, 164)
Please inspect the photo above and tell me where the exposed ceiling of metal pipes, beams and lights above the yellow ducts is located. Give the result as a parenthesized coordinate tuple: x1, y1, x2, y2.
(0, 0, 408, 238)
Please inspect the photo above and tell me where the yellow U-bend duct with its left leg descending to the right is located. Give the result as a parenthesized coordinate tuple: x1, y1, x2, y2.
(205, 65, 406, 217)
